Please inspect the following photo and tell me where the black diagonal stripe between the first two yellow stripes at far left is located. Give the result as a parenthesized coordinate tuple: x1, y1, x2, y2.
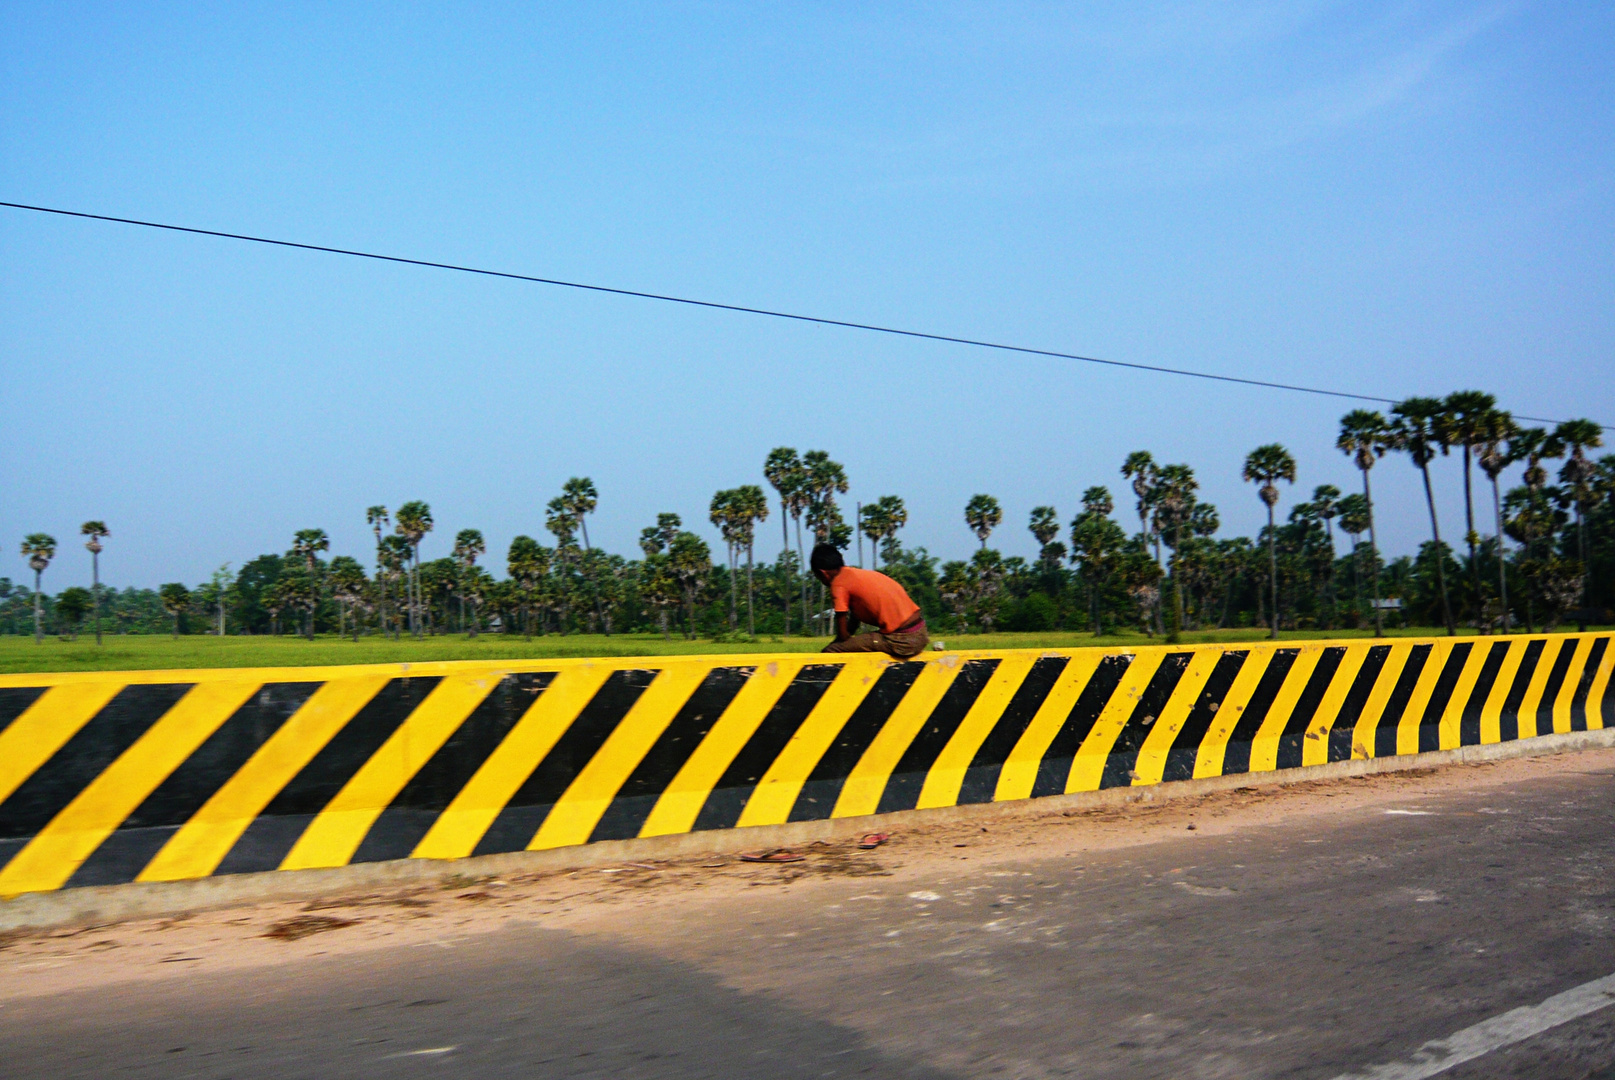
(0, 683, 192, 867)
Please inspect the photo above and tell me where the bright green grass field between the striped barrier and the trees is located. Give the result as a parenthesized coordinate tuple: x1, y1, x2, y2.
(0, 628, 1589, 673)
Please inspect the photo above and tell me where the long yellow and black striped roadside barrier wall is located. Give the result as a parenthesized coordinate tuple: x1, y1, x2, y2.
(0, 634, 1615, 896)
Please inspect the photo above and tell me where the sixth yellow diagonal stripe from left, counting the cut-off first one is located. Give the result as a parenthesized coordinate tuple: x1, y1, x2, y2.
(528, 663, 715, 851)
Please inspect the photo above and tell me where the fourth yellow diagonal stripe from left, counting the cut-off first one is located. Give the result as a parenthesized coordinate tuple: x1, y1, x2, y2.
(281, 672, 501, 870)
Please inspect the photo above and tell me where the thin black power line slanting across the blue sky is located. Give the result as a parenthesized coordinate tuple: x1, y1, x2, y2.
(0, 202, 1612, 431)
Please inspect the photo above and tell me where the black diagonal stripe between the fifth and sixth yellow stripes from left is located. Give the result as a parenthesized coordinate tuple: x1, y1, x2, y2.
(475, 668, 659, 856)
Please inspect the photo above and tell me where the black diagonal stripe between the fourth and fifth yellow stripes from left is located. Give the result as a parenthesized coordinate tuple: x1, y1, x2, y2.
(350, 672, 556, 862)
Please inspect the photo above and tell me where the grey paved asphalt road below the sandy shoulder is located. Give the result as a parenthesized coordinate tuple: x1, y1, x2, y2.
(0, 752, 1615, 1080)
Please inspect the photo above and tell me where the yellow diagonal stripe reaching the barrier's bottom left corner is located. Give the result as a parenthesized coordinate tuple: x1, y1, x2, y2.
(0, 681, 258, 896)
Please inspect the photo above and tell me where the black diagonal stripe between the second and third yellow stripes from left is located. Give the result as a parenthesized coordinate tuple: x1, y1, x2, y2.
(68, 683, 320, 888)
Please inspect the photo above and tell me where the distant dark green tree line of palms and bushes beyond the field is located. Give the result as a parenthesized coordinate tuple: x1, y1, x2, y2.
(12, 391, 1615, 639)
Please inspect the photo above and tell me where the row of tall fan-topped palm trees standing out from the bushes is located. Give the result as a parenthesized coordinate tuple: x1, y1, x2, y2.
(12, 391, 1602, 641)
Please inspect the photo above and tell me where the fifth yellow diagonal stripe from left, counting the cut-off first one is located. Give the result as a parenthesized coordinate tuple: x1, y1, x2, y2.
(410, 663, 617, 859)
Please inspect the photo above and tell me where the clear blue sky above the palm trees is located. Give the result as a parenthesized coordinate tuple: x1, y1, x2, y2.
(0, 2, 1615, 589)
